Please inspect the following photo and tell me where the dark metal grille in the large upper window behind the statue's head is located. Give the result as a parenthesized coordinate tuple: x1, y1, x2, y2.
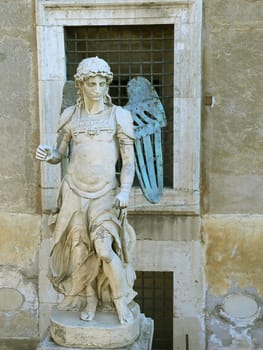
(65, 25, 174, 187)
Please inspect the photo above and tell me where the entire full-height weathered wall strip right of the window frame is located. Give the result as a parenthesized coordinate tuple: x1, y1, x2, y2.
(202, 0, 263, 350)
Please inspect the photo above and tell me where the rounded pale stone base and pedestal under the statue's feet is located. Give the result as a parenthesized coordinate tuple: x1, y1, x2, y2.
(37, 303, 153, 350)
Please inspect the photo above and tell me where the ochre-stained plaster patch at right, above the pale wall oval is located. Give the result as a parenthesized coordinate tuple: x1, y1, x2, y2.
(203, 215, 263, 295)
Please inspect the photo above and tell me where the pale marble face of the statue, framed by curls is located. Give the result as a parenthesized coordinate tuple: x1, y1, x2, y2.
(82, 75, 108, 101)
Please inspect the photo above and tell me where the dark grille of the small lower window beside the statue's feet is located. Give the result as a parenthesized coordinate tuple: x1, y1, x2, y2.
(135, 271, 173, 350)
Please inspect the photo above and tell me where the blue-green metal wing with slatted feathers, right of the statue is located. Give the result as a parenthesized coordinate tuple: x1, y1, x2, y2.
(124, 77, 166, 203)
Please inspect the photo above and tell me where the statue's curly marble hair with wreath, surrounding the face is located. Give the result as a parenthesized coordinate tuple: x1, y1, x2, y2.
(74, 56, 113, 107)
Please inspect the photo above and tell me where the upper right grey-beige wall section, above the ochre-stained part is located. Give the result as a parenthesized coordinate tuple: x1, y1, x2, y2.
(202, 0, 263, 214)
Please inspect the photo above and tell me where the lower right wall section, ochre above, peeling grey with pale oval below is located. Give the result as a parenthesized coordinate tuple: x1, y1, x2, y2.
(203, 215, 263, 350)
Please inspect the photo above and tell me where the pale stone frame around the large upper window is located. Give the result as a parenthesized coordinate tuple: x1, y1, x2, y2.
(36, 0, 202, 214)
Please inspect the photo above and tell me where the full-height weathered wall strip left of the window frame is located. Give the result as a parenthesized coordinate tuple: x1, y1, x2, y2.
(0, 0, 40, 350)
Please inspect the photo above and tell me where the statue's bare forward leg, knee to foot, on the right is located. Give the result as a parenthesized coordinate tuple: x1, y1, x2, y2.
(94, 227, 133, 323)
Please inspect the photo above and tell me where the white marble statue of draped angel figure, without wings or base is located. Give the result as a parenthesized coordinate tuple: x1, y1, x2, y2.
(36, 57, 136, 324)
